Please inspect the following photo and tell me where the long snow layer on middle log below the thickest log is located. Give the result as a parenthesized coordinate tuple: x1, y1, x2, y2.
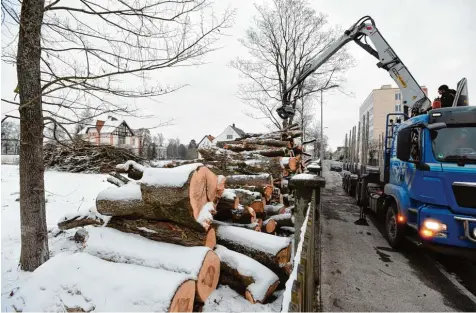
(83, 227, 210, 279)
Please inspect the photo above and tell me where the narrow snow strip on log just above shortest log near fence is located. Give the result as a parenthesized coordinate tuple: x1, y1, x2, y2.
(217, 226, 291, 255)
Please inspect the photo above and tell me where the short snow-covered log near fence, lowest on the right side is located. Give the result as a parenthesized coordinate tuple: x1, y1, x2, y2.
(215, 245, 279, 303)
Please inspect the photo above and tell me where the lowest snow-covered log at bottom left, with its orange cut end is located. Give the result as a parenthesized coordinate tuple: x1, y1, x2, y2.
(15, 253, 195, 312)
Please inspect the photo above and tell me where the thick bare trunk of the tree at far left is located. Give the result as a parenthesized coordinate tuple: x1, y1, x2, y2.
(17, 0, 49, 271)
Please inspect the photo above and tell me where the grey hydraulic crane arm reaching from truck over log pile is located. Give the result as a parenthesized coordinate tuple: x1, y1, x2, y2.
(277, 16, 431, 118)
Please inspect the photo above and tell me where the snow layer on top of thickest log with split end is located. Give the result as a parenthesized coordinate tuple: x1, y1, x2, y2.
(141, 163, 203, 187)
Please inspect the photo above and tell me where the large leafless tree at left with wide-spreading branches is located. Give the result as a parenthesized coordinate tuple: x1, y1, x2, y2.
(2, 0, 232, 271)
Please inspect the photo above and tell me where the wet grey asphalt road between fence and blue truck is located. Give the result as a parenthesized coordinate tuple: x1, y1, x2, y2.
(320, 164, 476, 312)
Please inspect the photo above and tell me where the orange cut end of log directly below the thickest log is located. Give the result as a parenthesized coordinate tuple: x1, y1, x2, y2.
(196, 251, 220, 302)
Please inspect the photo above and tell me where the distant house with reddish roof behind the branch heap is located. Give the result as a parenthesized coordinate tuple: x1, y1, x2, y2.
(78, 116, 142, 154)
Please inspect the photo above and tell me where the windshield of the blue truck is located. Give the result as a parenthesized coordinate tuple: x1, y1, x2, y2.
(430, 126, 476, 163)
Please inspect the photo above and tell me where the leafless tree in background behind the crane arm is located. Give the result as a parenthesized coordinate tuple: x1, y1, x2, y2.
(231, 0, 353, 129)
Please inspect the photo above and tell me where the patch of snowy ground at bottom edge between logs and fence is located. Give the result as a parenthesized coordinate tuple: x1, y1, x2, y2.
(202, 285, 282, 313)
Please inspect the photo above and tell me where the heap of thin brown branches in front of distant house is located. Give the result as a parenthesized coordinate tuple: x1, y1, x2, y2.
(43, 140, 144, 173)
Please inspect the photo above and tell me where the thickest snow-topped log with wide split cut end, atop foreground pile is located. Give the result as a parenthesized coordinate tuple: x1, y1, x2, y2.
(98, 163, 218, 229)
